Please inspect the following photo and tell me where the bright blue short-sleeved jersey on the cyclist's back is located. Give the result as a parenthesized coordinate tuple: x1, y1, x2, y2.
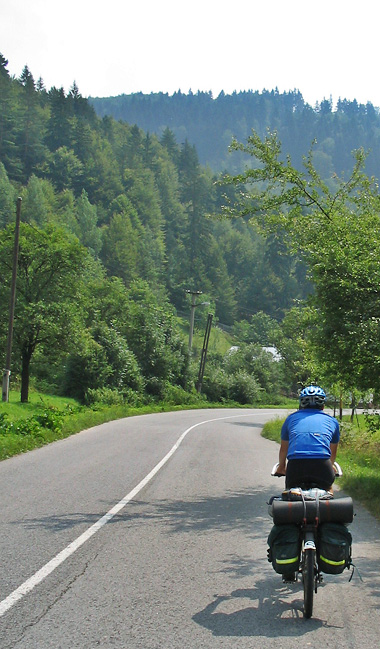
(281, 408, 339, 460)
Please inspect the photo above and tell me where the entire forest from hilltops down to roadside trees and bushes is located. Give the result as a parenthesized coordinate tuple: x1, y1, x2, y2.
(0, 55, 380, 403)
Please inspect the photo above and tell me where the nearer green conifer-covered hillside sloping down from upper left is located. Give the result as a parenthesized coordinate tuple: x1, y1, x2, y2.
(0, 53, 304, 324)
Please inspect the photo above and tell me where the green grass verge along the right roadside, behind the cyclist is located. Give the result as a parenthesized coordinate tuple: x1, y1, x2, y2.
(263, 415, 380, 518)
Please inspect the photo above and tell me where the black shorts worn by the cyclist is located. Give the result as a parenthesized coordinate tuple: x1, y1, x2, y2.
(285, 460, 335, 489)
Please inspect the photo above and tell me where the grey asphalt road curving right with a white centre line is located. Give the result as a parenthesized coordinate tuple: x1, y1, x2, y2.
(0, 409, 380, 649)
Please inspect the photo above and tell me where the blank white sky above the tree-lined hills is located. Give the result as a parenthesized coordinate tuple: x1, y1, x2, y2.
(0, 0, 380, 106)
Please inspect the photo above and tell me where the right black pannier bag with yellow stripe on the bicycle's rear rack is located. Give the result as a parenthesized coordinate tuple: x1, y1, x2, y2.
(317, 523, 352, 575)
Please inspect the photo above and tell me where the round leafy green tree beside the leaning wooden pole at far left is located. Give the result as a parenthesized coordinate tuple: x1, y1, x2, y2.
(0, 223, 87, 402)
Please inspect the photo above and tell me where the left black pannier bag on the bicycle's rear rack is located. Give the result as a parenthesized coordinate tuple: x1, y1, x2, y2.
(268, 523, 301, 575)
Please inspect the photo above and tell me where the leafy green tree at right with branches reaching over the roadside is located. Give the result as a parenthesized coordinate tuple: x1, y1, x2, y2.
(225, 132, 380, 391)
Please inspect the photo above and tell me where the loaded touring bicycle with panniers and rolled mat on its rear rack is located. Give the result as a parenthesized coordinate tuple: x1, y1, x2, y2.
(268, 462, 354, 618)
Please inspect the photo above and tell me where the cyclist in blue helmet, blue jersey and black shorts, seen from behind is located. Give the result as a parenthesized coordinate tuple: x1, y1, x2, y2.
(276, 385, 340, 492)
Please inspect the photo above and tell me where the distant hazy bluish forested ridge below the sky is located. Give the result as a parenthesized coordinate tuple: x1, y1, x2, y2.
(90, 90, 380, 178)
